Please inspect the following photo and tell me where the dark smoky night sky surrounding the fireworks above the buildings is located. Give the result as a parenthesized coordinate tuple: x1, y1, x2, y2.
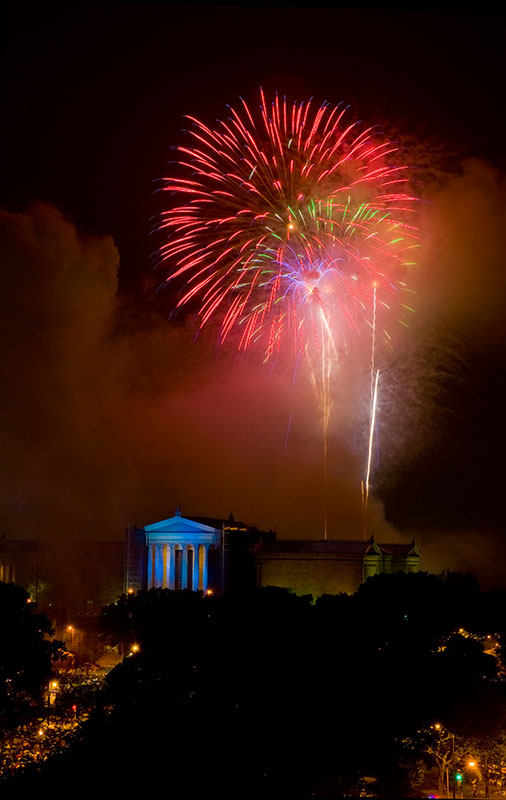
(0, 2, 506, 585)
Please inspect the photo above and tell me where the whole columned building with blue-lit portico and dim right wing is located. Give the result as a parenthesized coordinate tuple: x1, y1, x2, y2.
(125, 510, 420, 595)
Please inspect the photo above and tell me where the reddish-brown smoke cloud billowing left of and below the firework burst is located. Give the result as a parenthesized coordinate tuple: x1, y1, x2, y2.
(0, 205, 368, 540)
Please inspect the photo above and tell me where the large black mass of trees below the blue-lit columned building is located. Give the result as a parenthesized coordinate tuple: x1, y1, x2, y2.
(7, 573, 506, 799)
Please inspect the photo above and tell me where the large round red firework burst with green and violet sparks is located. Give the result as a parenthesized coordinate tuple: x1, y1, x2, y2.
(157, 91, 418, 532)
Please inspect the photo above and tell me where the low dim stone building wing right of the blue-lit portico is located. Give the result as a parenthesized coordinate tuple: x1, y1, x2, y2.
(253, 538, 420, 595)
